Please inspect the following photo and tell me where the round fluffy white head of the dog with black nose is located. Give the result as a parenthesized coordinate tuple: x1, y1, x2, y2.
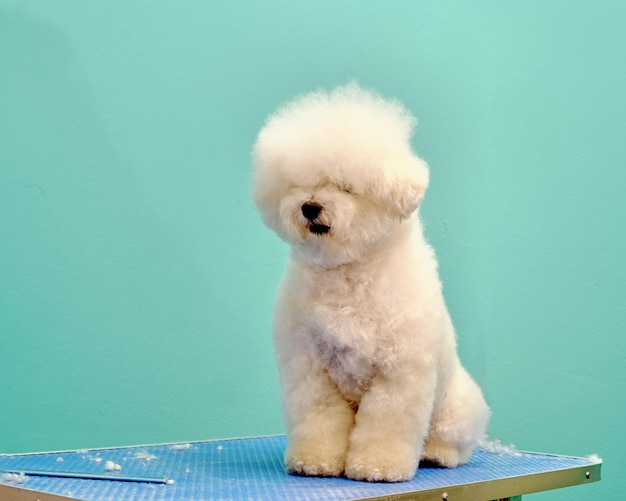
(254, 83, 428, 267)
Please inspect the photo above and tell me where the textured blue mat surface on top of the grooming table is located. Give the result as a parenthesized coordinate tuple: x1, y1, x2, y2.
(0, 436, 594, 501)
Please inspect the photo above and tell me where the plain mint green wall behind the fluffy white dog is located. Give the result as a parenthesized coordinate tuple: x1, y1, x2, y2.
(0, 0, 626, 500)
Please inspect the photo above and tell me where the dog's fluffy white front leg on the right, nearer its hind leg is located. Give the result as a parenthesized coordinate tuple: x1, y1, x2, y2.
(345, 371, 435, 482)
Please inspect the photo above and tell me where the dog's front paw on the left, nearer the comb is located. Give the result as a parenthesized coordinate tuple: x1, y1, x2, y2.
(285, 440, 346, 477)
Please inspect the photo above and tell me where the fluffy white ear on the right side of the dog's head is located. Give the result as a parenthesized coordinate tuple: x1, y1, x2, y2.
(384, 154, 429, 219)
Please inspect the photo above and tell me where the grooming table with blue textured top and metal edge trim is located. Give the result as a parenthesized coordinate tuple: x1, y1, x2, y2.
(0, 435, 601, 501)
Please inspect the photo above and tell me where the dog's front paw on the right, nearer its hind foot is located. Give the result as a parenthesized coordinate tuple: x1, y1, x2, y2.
(345, 449, 417, 482)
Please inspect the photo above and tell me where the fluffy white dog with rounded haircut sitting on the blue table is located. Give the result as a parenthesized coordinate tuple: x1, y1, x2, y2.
(254, 83, 490, 482)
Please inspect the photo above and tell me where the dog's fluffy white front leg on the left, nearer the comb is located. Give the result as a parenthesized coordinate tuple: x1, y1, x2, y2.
(281, 357, 354, 477)
